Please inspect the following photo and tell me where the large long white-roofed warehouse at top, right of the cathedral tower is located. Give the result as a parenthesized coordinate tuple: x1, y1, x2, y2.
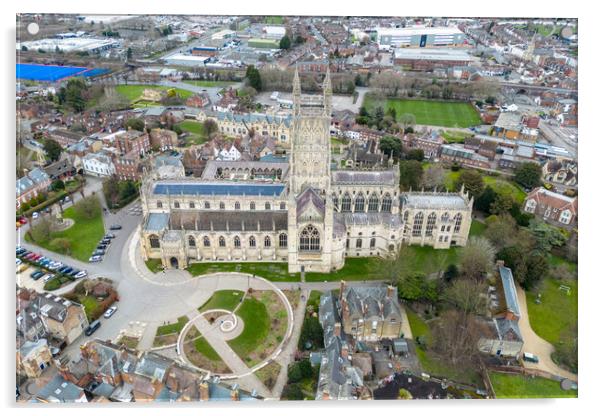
(376, 26, 466, 49)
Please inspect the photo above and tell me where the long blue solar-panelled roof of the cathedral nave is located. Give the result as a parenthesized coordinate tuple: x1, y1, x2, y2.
(153, 182, 285, 196)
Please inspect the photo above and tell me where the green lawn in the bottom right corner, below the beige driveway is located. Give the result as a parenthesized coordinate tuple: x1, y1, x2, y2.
(489, 373, 577, 399)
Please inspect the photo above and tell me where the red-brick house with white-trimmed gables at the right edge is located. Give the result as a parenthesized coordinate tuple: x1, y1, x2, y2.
(523, 187, 577, 228)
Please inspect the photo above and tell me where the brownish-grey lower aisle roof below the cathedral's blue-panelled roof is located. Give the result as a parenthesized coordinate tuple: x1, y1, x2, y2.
(169, 210, 288, 231)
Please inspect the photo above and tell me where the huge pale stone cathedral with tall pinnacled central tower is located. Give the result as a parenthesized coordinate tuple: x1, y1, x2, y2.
(140, 69, 473, 272)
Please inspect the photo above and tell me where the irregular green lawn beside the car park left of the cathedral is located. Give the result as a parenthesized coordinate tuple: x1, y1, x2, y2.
(26, 200, 105, 262)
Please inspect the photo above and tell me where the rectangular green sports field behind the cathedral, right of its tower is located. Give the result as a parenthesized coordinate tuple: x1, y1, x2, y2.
(364, 96, 481, 127)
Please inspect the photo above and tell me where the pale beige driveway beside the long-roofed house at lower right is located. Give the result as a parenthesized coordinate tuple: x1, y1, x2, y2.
(516, 287, 577, 381)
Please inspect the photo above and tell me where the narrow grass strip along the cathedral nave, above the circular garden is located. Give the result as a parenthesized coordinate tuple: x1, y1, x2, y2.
(186, 263, 300, 282)
